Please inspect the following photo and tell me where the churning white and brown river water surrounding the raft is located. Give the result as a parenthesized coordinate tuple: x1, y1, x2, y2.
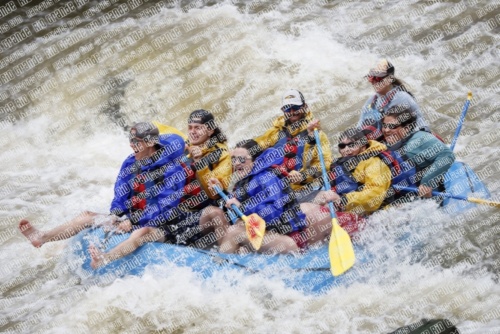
(0, 0, 500, 333)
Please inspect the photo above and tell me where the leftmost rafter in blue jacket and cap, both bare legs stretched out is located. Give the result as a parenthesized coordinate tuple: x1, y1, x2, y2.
(19, 122, 186, 268)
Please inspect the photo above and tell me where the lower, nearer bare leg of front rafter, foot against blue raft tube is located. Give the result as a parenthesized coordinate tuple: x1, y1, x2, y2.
(89, 227, 165, 269)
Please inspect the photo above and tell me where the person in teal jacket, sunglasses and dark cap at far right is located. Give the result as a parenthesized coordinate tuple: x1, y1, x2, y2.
(382, 105, 455, 197)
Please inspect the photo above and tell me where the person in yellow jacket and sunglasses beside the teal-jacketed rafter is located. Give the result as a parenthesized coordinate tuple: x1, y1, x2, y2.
(315, 128, 391, 215)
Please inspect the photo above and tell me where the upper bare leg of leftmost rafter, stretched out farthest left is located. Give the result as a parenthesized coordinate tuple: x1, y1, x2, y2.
(19, 211, 99, 247)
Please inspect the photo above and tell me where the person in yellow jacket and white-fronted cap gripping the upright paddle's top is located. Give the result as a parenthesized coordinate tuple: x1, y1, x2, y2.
(255, 89, 332, 198)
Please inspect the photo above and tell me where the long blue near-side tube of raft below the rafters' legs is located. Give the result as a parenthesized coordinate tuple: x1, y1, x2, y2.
(70, 228, 363, 293)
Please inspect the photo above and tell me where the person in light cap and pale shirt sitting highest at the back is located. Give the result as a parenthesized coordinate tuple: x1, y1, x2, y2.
(358, 59, 430, 132)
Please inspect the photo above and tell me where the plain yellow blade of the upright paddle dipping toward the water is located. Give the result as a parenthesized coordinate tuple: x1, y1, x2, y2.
(328, 218, 356, 276)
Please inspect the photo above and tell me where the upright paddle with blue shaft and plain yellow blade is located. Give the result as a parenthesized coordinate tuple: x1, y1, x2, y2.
(314, 129, 356, 276)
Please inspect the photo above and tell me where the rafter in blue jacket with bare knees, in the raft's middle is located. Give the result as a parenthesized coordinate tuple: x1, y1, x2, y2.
(220, 140, 307, 254)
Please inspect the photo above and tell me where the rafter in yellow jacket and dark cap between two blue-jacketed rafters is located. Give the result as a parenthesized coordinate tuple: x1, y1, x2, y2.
(172, 109, 232, 248)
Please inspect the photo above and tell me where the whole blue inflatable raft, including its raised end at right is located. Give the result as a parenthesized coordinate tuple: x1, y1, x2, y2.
(66, 162, 490, 294)
